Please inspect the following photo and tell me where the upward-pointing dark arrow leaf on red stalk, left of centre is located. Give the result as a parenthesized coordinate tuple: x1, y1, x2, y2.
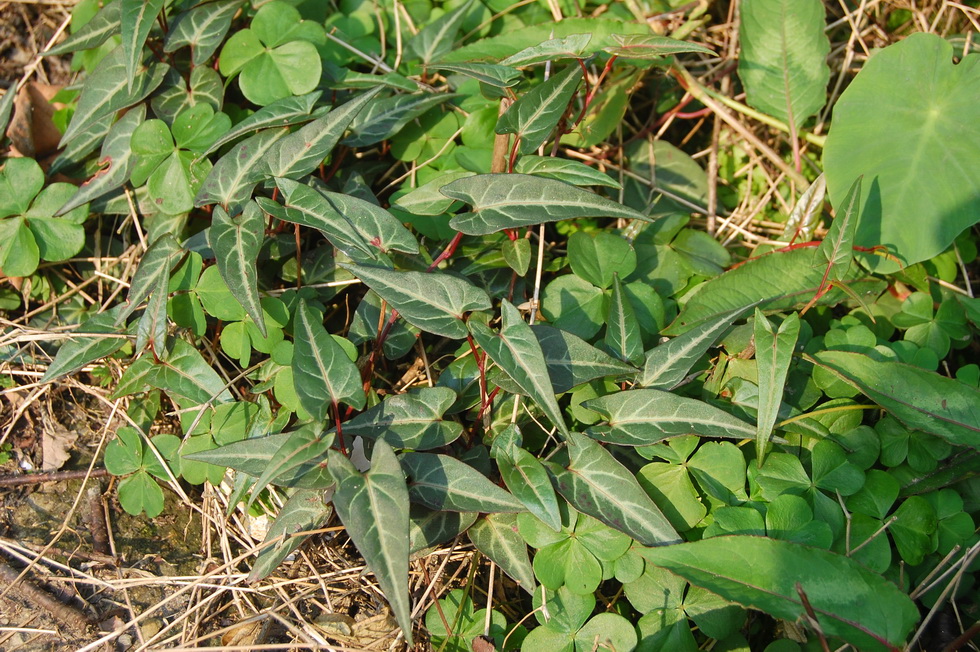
(292, 300, 366, 421)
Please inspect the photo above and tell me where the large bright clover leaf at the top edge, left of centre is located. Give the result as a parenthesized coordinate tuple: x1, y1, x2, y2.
(218, 0, 325, 106)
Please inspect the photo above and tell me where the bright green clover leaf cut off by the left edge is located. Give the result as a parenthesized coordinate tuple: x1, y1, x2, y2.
(0, 158, 88, 277)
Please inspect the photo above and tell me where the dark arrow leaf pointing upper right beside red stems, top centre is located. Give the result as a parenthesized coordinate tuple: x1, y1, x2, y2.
(496, 66, 582, 154)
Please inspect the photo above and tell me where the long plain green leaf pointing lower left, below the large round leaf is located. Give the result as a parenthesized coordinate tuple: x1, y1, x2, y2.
(663, 247, 885, 335)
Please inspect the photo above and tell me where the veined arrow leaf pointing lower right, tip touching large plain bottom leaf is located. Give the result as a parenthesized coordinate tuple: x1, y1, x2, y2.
(554, 432, 680, 546)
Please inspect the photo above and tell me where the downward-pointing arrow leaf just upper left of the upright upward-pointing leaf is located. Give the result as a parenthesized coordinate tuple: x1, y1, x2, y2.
(208, 202, 267, 337)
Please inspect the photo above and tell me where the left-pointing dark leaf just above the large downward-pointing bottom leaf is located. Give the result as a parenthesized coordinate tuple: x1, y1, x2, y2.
(344, 387, 463, 450)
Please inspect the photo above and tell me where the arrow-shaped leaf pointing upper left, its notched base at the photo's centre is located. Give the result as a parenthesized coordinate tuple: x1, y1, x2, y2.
(343, 265, 491, 340)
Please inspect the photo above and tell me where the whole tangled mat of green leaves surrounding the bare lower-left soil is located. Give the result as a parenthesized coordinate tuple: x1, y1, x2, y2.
(0, 0, 980, 652)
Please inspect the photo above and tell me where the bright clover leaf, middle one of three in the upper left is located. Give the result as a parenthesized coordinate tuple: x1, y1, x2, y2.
(130, 104, 231, 215)
